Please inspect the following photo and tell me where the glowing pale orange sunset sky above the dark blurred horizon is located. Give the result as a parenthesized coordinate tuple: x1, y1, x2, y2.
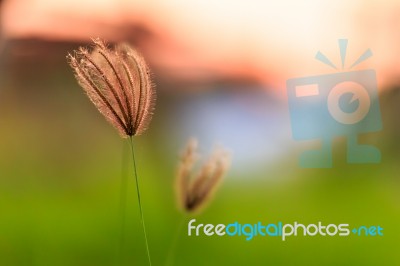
(1, 0, 400, 89)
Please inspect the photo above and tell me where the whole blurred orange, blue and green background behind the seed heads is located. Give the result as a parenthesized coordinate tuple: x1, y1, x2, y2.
(0, 0, 400, 266)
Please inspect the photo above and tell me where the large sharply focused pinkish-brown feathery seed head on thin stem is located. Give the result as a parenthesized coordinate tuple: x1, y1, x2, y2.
(67, 39, 156, 137)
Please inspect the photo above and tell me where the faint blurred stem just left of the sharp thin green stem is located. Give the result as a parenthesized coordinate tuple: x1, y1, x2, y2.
(118, 140, 128, 265)
